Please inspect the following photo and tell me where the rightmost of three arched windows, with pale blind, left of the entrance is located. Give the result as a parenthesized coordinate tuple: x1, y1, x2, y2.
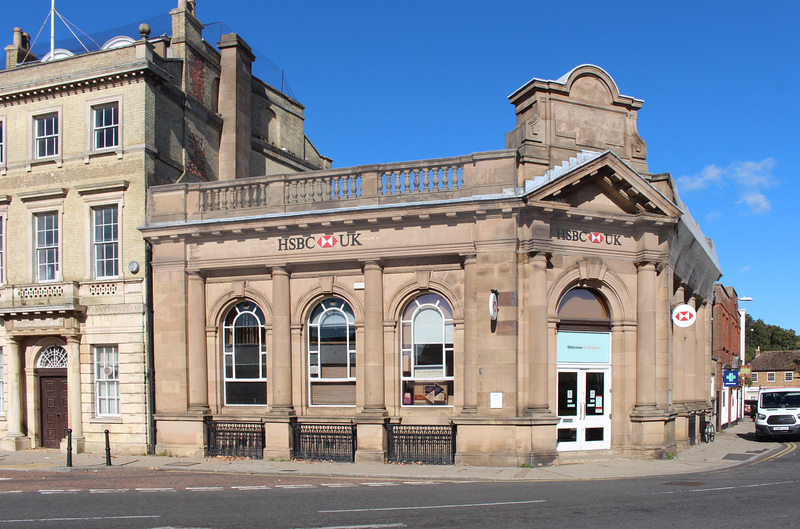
(401, 293, 453, 406)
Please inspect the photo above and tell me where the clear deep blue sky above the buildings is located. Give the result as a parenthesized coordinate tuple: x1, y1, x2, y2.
(6, 0, 800, 332)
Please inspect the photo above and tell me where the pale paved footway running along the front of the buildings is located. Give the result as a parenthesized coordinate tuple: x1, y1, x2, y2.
(0, 419, 782, 481)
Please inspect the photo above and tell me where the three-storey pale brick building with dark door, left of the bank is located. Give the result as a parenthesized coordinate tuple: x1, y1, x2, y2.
(0, 0, 330, 453)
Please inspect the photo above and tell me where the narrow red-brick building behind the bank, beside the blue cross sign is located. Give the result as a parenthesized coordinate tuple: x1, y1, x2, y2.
(711, 283, 743, 428)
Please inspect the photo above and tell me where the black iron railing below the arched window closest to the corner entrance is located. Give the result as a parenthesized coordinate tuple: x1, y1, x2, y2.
(386, 423, 456, 465)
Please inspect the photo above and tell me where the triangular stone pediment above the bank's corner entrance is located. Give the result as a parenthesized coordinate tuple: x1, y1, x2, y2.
(525, 151, 682, 220)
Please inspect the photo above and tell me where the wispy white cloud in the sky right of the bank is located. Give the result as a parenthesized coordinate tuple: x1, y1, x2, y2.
(677, 158, 778, 214)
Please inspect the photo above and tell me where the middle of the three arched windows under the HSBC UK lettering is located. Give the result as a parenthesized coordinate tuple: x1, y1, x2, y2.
(307, 298, 356, 406)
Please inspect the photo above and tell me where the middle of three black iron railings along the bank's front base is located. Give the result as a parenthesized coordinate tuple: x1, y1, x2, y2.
(292, 422, 356, 463)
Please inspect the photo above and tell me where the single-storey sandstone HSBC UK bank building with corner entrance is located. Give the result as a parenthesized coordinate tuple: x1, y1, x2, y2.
(142, 65, 720, 466)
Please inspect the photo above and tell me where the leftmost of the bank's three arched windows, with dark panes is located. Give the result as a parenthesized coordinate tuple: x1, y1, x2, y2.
(223, 301, 267, 405)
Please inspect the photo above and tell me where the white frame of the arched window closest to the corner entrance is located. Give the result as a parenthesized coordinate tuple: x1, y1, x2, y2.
(400, 292, 455, 407)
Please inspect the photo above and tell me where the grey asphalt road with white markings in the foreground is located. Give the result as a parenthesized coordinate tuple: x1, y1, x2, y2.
(0, 443, 800, 529)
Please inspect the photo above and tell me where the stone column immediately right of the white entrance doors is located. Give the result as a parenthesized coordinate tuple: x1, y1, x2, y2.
(634, 262, 657, 412)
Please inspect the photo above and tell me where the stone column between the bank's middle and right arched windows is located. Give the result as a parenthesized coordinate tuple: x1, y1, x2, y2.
(361, 261, 386, 416)
